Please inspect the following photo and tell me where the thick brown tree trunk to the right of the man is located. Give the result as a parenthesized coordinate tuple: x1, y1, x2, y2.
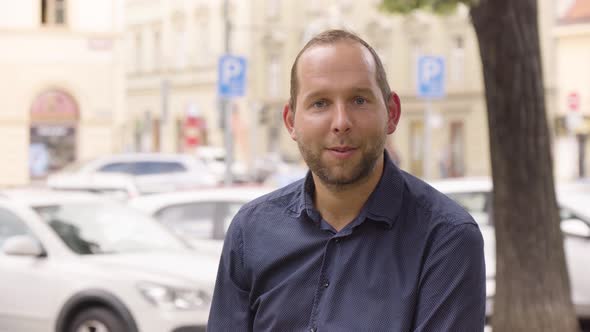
(471, 0, 579, 332)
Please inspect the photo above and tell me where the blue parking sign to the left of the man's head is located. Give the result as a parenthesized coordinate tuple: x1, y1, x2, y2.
(218, 55, 246, 98)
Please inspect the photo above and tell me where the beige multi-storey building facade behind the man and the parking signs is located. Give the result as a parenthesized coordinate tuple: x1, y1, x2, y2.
(126, 0, 556, 178)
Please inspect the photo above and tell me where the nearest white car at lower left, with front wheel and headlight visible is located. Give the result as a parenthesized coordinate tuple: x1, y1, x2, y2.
(0, 190, 219, 332)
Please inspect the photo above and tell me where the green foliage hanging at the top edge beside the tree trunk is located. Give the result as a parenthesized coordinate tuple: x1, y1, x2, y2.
(379, 0, 477, 15)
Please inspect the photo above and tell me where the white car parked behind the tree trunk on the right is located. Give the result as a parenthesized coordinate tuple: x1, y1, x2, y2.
(431, 178, 590, 320)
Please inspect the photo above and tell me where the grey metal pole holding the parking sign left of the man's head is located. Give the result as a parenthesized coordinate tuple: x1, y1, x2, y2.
(221, 0, 234, 186)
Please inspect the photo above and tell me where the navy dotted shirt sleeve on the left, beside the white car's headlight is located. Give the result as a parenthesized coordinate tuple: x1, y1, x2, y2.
(207, 220, 252, 332)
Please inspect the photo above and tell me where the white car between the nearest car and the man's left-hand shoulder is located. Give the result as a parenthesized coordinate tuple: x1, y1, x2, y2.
(128, 186, 272, 255)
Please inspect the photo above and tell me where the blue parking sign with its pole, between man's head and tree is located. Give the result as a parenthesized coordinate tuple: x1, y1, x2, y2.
(416, 55, 445, 178)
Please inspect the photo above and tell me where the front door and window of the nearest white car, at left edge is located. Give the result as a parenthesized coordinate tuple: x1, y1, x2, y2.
(0, 204, 59, 332)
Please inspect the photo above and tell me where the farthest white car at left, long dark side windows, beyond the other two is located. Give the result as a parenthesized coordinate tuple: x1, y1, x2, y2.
(47, 153, 219, 194)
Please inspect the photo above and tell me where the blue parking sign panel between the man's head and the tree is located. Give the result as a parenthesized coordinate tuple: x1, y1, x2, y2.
(417, 55, 445, 98)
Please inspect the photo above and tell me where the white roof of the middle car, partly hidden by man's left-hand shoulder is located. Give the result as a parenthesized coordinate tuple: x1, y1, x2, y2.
(128, 186, 275, 212)
